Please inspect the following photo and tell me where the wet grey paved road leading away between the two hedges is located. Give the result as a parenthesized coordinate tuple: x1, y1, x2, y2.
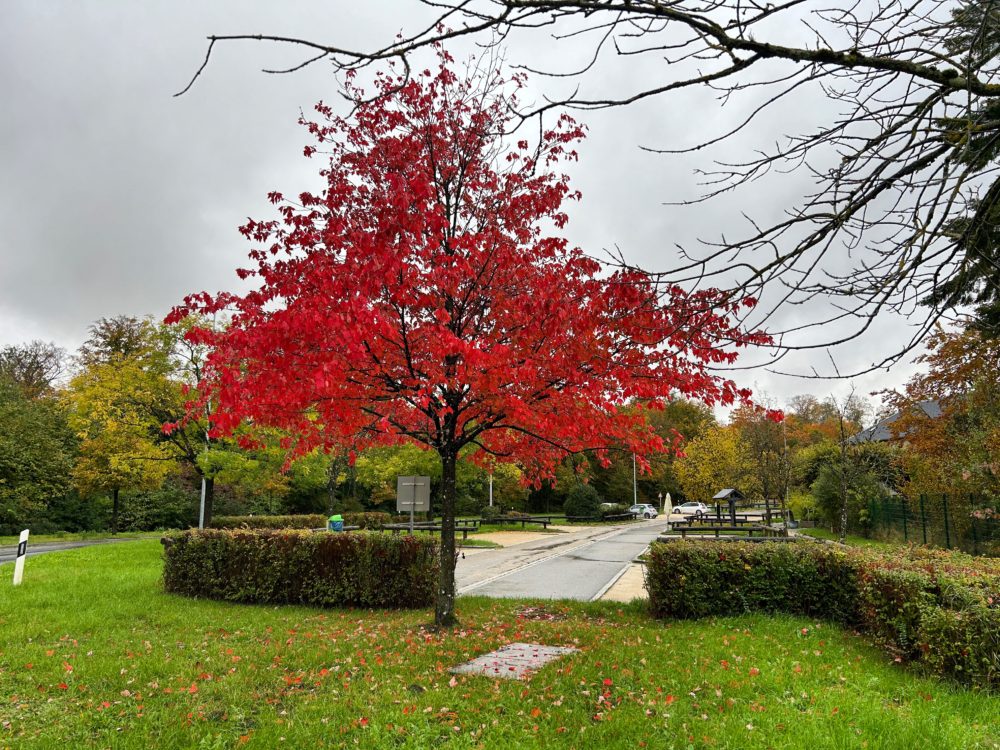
(456, 519, 667, 601)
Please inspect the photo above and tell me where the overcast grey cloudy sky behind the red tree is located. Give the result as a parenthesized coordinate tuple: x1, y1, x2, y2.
(0, 0, 913, 418)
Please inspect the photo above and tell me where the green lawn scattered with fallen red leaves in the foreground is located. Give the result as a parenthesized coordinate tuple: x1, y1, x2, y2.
(0, 541, 1000, 750)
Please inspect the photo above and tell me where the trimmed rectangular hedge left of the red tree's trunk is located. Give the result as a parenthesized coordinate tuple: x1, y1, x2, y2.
(163, 529, 439, 608)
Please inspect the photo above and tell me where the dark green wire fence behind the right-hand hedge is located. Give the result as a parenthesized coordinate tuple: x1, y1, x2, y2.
(864, 494, 1000, 557)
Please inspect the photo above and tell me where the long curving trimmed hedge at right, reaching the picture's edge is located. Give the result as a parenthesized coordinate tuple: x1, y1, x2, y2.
(646, 541, 1000, 689)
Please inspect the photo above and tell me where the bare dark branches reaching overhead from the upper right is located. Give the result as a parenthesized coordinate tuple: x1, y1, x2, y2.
(181, 0, 1000, 371)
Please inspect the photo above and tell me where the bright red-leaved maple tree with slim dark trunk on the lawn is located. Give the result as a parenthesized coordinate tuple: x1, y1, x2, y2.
(168, 52, 766, 626)
